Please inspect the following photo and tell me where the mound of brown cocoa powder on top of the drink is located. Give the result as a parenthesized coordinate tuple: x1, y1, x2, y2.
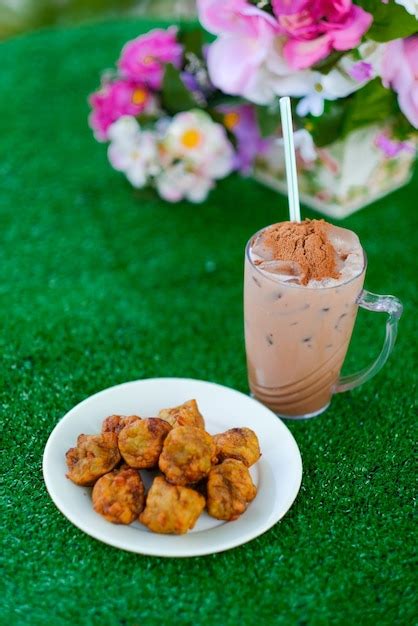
(263, 219, 340, 285)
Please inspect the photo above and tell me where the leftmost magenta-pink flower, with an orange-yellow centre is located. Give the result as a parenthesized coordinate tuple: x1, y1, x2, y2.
(89, 80, 151, 141)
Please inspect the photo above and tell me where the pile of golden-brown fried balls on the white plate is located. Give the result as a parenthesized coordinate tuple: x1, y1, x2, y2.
(66, 400, 261, 535)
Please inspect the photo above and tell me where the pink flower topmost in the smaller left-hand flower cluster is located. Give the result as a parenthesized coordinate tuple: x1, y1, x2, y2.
(118, 27, 183, 90)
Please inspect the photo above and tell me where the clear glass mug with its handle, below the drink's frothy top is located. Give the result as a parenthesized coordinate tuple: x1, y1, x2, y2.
(244, 224, 402, 419)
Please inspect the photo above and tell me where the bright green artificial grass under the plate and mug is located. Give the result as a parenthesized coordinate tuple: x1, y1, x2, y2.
(0, 22, 418, 626)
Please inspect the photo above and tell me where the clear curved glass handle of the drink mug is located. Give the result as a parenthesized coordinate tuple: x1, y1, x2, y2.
(334, 289, 403, 393)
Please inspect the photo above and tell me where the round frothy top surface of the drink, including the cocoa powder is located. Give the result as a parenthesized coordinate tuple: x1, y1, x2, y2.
(249, 220, 364, 288)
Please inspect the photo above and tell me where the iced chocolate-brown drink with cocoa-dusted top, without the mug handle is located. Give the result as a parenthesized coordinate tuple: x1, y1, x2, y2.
(244, 220, 365, 417)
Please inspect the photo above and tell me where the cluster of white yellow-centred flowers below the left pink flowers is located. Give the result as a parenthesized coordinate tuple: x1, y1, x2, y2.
(108, 110, 234, 202)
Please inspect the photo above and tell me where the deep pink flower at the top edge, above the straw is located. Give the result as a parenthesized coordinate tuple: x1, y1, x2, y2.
(273, 0, 373, 69)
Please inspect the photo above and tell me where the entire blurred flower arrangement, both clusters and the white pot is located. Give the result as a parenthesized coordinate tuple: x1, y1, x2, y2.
(90, 0, 418, 216)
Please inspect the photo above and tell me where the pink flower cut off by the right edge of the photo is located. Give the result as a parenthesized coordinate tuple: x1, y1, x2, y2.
(382, 35, 418, 128)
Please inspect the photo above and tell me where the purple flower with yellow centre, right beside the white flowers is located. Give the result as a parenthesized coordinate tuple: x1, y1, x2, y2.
(218, 104, 270, 174)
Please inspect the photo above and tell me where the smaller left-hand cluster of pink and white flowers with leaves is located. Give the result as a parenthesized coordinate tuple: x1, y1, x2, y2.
(89, 27, 240, 202)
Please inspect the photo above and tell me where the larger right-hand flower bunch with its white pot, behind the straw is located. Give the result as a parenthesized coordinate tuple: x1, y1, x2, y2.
(198, 0, 418, 217)
